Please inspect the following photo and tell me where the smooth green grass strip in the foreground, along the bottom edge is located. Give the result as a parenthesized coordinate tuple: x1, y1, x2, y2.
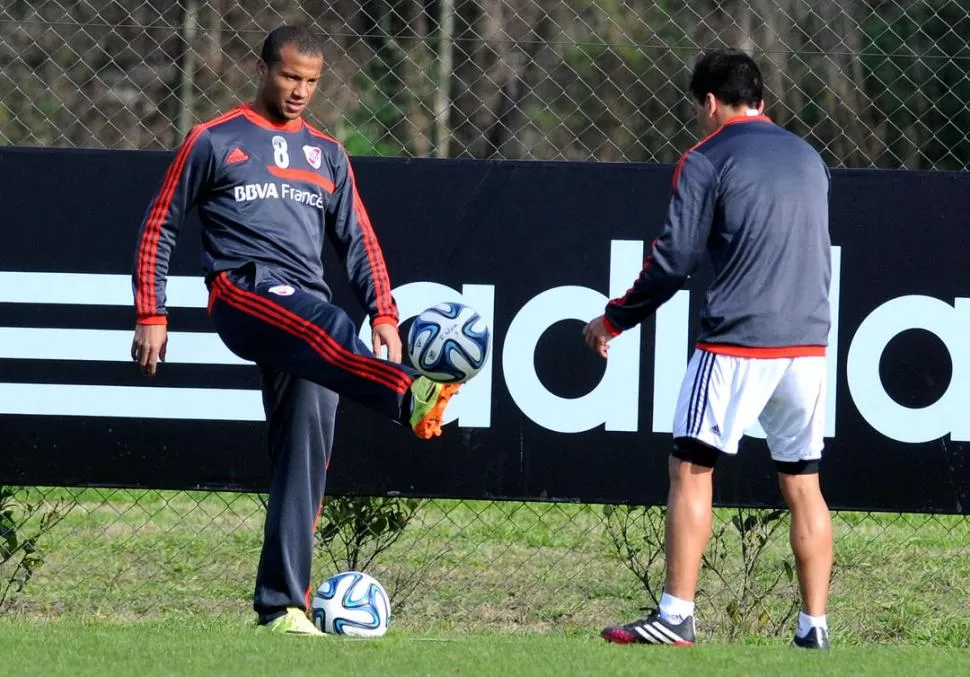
(0, 620, 970, 677)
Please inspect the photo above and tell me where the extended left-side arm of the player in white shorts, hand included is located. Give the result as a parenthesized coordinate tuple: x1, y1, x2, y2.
(585, 152, 717, 357)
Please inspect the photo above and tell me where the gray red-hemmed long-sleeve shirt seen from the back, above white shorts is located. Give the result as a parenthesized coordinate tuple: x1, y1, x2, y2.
(605, 115, 831, 357)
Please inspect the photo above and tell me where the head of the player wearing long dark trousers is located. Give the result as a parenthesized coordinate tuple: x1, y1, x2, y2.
(256, 26, 323, 122)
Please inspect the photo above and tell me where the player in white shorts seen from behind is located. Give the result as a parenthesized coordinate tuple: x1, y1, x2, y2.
(584, 50, 832, 649)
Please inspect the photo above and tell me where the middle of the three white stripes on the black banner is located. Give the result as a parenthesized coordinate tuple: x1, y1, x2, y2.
(0, 327, 251, 364)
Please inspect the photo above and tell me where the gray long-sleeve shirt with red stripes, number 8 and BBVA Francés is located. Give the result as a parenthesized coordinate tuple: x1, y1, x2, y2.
(132, 105, 398, 325)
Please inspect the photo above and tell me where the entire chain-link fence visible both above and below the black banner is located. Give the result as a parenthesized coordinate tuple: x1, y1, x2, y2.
(0, 0, 970, 646)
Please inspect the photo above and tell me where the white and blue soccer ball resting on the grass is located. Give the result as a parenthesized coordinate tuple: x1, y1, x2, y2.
(312, 571, 391, 637)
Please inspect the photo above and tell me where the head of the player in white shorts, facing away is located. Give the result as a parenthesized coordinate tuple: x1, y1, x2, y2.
(690, 49, 764, 133)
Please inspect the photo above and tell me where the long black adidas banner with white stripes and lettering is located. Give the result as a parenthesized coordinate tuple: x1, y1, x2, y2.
(0, 148, 970, 513)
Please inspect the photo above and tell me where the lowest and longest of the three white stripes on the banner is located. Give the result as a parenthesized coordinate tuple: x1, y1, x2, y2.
(0, 383, 265, 421)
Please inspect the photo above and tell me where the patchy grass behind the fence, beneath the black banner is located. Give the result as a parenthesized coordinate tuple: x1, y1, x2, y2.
(0, 489, 970, 648)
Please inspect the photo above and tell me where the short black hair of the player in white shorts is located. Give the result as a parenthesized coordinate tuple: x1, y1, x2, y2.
(690, 49, 764, 107)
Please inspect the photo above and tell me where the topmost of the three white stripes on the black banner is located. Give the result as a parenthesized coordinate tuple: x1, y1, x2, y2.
(0, 271, 209, 308)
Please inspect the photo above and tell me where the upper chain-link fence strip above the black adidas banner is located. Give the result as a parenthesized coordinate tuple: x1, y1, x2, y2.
(0, 0, 970, 169)
